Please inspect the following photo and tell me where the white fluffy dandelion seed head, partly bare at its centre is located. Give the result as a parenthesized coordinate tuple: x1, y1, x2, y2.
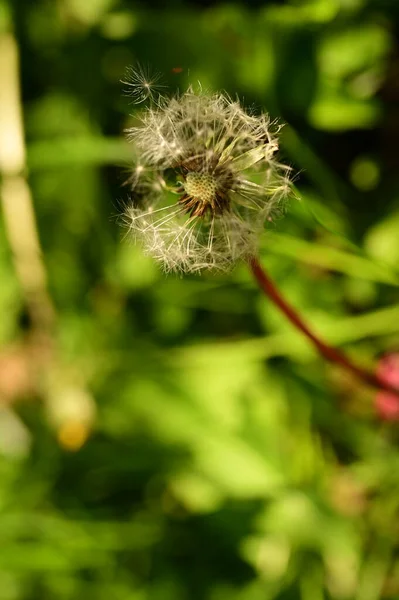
(126, 77, 290, 272)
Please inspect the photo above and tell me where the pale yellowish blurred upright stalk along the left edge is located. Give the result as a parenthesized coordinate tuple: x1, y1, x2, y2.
(0, 32, 55, 332)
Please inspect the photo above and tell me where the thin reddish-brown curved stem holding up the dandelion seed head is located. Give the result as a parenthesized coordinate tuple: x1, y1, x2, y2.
(249, 257, 399, 397)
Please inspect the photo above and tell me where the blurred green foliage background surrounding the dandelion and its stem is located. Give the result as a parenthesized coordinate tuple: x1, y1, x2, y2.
(0, 0, 399, 600)
